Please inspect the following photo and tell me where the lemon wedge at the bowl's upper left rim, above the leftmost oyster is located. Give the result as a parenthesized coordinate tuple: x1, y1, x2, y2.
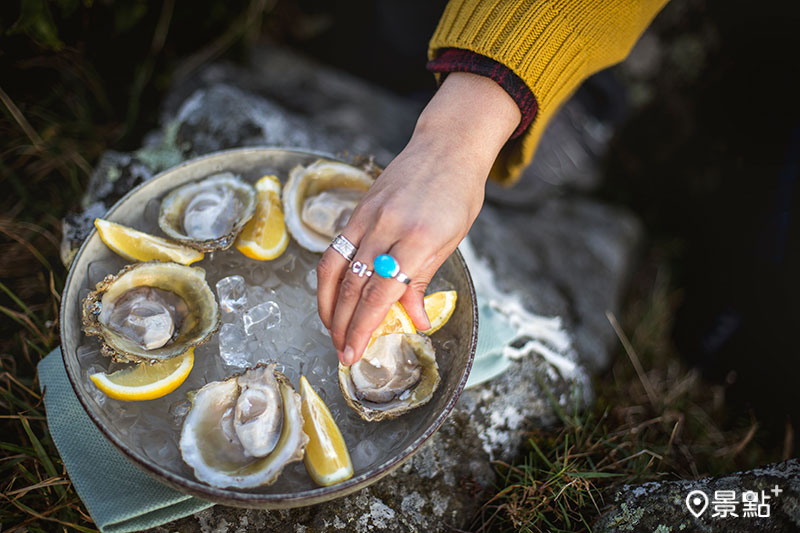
(94, 218, 203, 265)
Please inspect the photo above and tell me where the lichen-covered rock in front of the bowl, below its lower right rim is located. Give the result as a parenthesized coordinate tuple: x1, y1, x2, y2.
(150, 356, 583, 533)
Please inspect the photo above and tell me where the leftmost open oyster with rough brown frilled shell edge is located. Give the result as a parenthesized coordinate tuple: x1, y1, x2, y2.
(82, 261, 220, 362)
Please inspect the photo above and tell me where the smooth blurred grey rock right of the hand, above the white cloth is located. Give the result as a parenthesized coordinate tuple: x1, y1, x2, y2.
(470, 197, 642, 371)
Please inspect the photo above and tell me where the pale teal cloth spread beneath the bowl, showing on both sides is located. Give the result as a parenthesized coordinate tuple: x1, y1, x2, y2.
(38, 242, 573, 533)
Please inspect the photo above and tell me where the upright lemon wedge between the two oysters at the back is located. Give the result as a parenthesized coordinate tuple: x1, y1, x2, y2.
(236, 176, 289, 261)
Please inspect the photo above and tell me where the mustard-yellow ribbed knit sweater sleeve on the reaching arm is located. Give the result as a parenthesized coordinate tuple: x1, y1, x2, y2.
(428, 0, 667, 185)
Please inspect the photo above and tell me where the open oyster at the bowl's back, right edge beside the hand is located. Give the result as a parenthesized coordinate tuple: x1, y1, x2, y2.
(283, 159, 374, 252)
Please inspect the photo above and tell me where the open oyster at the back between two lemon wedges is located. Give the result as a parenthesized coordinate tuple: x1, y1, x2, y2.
(158, 172, 257, 252)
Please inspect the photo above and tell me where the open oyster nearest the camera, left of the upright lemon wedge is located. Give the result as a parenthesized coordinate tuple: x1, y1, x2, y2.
(180, 363, 308, 488)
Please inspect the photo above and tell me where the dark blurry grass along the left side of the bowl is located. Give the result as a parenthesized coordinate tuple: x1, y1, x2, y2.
(0, 0, 273, 532)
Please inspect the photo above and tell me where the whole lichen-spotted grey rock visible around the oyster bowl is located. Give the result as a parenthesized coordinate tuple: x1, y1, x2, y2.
(64, 43, 640, 532)
